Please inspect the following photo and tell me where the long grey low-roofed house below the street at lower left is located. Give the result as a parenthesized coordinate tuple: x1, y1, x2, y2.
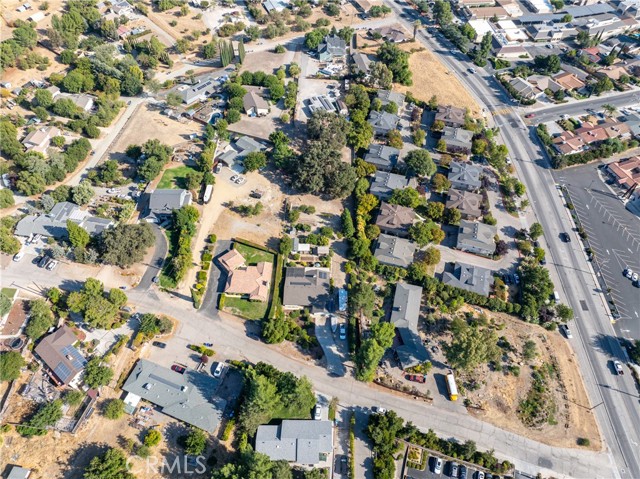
(122, 359, 227, 434)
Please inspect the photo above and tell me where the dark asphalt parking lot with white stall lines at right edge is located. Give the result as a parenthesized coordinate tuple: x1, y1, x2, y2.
(555, 164, 640, 339)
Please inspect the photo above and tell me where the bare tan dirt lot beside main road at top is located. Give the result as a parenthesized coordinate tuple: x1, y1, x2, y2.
(357, 33, 480, 117)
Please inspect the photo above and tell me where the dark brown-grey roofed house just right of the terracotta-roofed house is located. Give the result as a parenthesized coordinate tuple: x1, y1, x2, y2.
(282, 267, 331, 313)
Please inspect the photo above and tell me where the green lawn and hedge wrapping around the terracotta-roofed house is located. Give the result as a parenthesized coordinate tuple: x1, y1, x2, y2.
(218, 238, 282, 320)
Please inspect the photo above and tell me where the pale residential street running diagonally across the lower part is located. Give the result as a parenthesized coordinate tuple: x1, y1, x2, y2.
(1, 262, 620, 479)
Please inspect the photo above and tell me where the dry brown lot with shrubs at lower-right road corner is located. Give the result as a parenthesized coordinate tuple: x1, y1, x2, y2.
(456, 312, 602, 450)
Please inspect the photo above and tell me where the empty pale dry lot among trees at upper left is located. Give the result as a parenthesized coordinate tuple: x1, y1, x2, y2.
(111, 104, 202, 153)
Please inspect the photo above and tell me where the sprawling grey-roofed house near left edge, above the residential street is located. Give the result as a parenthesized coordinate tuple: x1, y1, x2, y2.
(14, 201, 114, 239)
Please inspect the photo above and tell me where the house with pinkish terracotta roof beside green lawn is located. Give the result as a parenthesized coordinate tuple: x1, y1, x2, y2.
(220, 249, 273, 301)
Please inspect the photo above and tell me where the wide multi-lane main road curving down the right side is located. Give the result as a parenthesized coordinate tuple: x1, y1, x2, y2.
(387, 2, 640, 478)
